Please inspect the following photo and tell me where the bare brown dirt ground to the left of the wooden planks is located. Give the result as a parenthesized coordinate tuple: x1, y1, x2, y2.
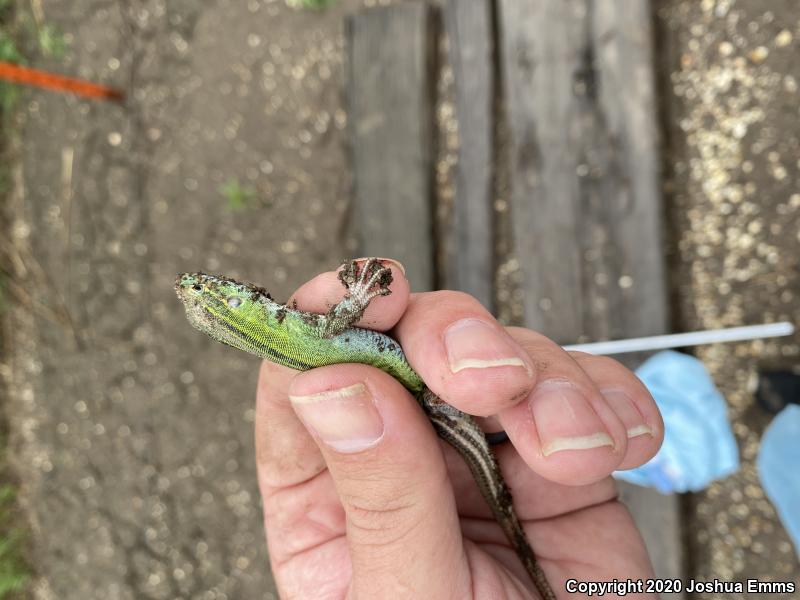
(4, 0, 364, 599)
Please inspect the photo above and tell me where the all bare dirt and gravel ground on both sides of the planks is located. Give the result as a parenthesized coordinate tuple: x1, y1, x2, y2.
(0, 0, 800, 600)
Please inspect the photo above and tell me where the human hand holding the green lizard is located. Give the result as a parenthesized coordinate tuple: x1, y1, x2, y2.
(256, 265, 663, 599)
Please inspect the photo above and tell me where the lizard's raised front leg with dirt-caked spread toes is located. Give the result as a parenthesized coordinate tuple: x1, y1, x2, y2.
(321, 258, 392, 338)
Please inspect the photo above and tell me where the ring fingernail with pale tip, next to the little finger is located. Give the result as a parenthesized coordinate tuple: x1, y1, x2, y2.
(530, 381, 614, 456)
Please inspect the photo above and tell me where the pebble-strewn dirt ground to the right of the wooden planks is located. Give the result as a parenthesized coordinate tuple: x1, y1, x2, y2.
(656, 0, 800, 598)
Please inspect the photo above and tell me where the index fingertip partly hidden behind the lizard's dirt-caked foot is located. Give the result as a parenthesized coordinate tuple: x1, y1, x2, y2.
(289, 258, 410, 331)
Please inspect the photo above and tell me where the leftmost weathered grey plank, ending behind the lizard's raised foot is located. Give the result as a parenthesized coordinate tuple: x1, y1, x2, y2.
(346, 2, 435, 291)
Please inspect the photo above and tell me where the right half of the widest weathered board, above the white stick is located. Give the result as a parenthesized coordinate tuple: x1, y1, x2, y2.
(589, 0, 668, 337)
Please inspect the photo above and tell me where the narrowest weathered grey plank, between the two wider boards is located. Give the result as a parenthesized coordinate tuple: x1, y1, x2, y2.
(444, 0, 494, 310)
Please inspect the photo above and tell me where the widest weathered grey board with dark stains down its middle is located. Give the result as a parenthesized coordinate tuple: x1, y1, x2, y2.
(498, 0, 683, 597)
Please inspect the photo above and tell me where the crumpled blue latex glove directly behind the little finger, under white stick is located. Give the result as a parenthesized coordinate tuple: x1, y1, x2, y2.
(614, 350, 739, 494)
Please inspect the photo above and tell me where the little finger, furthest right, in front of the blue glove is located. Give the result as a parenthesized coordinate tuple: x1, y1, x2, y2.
(570, 352, 664, 469)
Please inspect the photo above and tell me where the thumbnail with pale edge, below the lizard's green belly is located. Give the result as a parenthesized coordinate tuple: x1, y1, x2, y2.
(289, 383, 383, 454)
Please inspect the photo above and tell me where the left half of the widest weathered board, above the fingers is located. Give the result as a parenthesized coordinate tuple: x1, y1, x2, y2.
(498, 0, 583, 342)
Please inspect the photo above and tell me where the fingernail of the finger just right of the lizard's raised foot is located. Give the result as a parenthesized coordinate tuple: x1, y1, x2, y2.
(444, 319, 531, 376)
